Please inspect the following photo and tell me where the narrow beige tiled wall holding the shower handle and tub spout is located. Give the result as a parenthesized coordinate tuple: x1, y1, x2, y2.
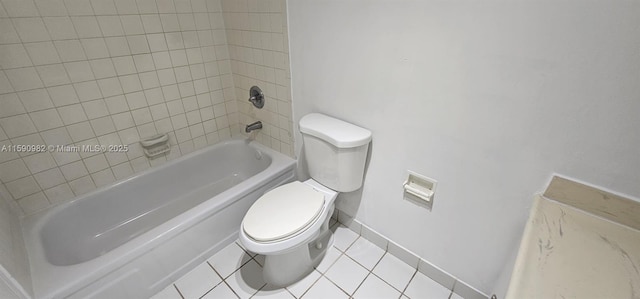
(219, 0, 294, 157)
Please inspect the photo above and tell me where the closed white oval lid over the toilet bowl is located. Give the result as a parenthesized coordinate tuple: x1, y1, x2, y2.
(242, 181, 324, 241)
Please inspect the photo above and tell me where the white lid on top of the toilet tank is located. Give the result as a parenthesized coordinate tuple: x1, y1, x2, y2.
(300, 113, 371, 148)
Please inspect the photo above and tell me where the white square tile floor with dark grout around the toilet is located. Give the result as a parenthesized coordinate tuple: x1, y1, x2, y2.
(152, 223, 462, 299)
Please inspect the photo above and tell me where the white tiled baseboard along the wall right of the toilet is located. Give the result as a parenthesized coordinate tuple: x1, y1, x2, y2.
(332, 209, 489, 299)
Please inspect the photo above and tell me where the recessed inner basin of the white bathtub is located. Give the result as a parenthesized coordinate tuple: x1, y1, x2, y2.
(40, 142, 271, 266)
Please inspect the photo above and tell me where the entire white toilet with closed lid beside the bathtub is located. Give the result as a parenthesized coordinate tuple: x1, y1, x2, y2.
(240, 113, 371, 287)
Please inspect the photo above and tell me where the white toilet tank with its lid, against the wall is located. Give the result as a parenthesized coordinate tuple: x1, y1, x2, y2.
(300, 113, 371, 192)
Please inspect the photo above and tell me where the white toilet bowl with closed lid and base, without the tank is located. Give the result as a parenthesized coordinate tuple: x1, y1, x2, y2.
(240, 180, 338, 286)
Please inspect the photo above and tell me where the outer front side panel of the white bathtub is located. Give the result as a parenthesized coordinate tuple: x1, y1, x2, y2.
(68, 172, 294, 299)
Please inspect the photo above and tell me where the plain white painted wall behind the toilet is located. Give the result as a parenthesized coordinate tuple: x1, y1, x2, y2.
(288, 0, 640, 293)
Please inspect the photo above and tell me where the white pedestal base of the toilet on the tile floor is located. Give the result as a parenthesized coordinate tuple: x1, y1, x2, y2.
(262, 230, 333, 287)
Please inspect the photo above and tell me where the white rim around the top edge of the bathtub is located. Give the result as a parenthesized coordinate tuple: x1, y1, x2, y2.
(21, 138, 296, 298)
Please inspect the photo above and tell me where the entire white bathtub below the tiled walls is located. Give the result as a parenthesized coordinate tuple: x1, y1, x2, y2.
(23, 140, 295, 298)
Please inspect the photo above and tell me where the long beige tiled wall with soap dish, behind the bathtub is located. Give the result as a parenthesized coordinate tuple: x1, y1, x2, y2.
(0, 0, 242, 214)
